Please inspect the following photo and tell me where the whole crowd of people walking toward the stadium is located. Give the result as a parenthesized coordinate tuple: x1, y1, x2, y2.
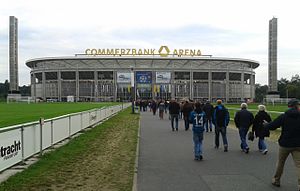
(139, 97, 300, 191)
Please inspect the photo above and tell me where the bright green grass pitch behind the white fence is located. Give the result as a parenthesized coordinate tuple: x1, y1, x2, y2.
(0, 103, 115, 128)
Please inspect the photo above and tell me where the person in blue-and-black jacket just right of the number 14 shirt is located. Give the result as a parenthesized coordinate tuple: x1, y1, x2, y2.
(212, 100, 229, 152)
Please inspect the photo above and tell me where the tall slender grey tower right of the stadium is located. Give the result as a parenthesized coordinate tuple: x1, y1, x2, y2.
(269, 17, 278, 94)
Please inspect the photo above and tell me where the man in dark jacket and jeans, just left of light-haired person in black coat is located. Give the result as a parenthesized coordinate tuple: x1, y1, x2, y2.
(234, 103, 254, 153)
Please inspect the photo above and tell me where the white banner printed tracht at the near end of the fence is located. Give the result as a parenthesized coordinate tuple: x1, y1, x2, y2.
(0, 129, 22, 171)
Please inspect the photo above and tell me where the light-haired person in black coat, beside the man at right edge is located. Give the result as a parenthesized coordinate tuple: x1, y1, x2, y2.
(252, 105, 272, 155)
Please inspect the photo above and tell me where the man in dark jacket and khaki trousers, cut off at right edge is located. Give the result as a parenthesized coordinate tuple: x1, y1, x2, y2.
(266, 99, 300, 191)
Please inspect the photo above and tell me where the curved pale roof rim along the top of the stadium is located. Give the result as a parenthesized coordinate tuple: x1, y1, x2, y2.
(25, 56, 260, 69)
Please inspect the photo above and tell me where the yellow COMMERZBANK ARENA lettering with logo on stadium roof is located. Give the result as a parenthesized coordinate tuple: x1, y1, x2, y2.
(85, 46, 202, 57)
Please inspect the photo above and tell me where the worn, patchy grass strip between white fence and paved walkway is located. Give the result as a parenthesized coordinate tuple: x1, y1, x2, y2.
(0, 108, 139, 191)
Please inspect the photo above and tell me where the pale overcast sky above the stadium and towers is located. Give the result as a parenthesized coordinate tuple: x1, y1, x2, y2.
(0, 0, 300, 85)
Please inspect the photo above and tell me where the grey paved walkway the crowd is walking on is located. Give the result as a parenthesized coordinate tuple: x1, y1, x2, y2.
(137, 112, 297, 191)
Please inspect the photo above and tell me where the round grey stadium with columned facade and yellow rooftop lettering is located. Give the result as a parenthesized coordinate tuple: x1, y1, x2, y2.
(26, 46, 259, 103)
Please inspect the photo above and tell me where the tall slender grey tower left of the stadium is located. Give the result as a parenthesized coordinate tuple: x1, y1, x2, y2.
(9, 16, 19, 93)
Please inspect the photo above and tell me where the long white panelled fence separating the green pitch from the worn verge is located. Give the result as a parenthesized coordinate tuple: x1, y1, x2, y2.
(0, 103, 131, 172)
